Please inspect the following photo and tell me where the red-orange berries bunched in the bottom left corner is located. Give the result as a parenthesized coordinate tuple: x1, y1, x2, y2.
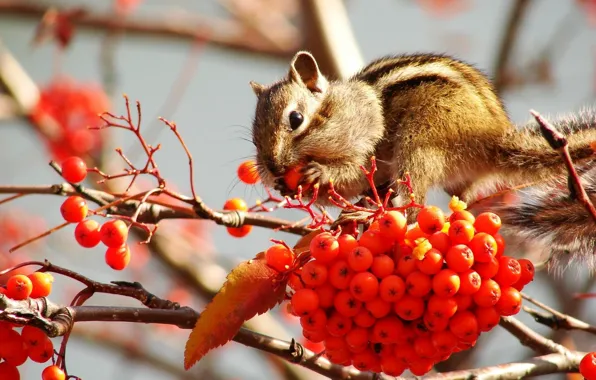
(0, 272, 66, 380)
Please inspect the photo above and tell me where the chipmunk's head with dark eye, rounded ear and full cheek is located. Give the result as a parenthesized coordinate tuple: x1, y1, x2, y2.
(251, 51, 383, 196)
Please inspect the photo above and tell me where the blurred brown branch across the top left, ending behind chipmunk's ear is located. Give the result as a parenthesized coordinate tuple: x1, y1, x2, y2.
(0, 0, 298, 58)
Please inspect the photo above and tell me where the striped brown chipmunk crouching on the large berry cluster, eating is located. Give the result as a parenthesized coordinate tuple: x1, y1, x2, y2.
(251, 51, 596, 268)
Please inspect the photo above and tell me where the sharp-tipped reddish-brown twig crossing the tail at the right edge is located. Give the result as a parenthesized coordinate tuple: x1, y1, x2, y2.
(530, 110, 596, 222)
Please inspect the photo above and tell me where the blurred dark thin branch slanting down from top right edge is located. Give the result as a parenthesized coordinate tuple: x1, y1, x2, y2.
(493, 0, 531, 93)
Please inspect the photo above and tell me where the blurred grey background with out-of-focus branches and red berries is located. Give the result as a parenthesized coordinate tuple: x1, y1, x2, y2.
(0, 0, 596, 380)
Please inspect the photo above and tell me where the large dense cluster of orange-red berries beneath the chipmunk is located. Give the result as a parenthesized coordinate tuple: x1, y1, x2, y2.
(265, 198, 534, 376)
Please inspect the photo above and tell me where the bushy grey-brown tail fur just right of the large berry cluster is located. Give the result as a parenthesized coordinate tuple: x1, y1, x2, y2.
(477, 167, 596, 270)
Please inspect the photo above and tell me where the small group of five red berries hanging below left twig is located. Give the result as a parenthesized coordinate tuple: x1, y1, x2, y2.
(60, 156, 130, 270)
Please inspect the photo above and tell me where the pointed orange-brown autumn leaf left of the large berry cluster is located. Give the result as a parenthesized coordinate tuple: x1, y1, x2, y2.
(184, 252, 287, 369)
